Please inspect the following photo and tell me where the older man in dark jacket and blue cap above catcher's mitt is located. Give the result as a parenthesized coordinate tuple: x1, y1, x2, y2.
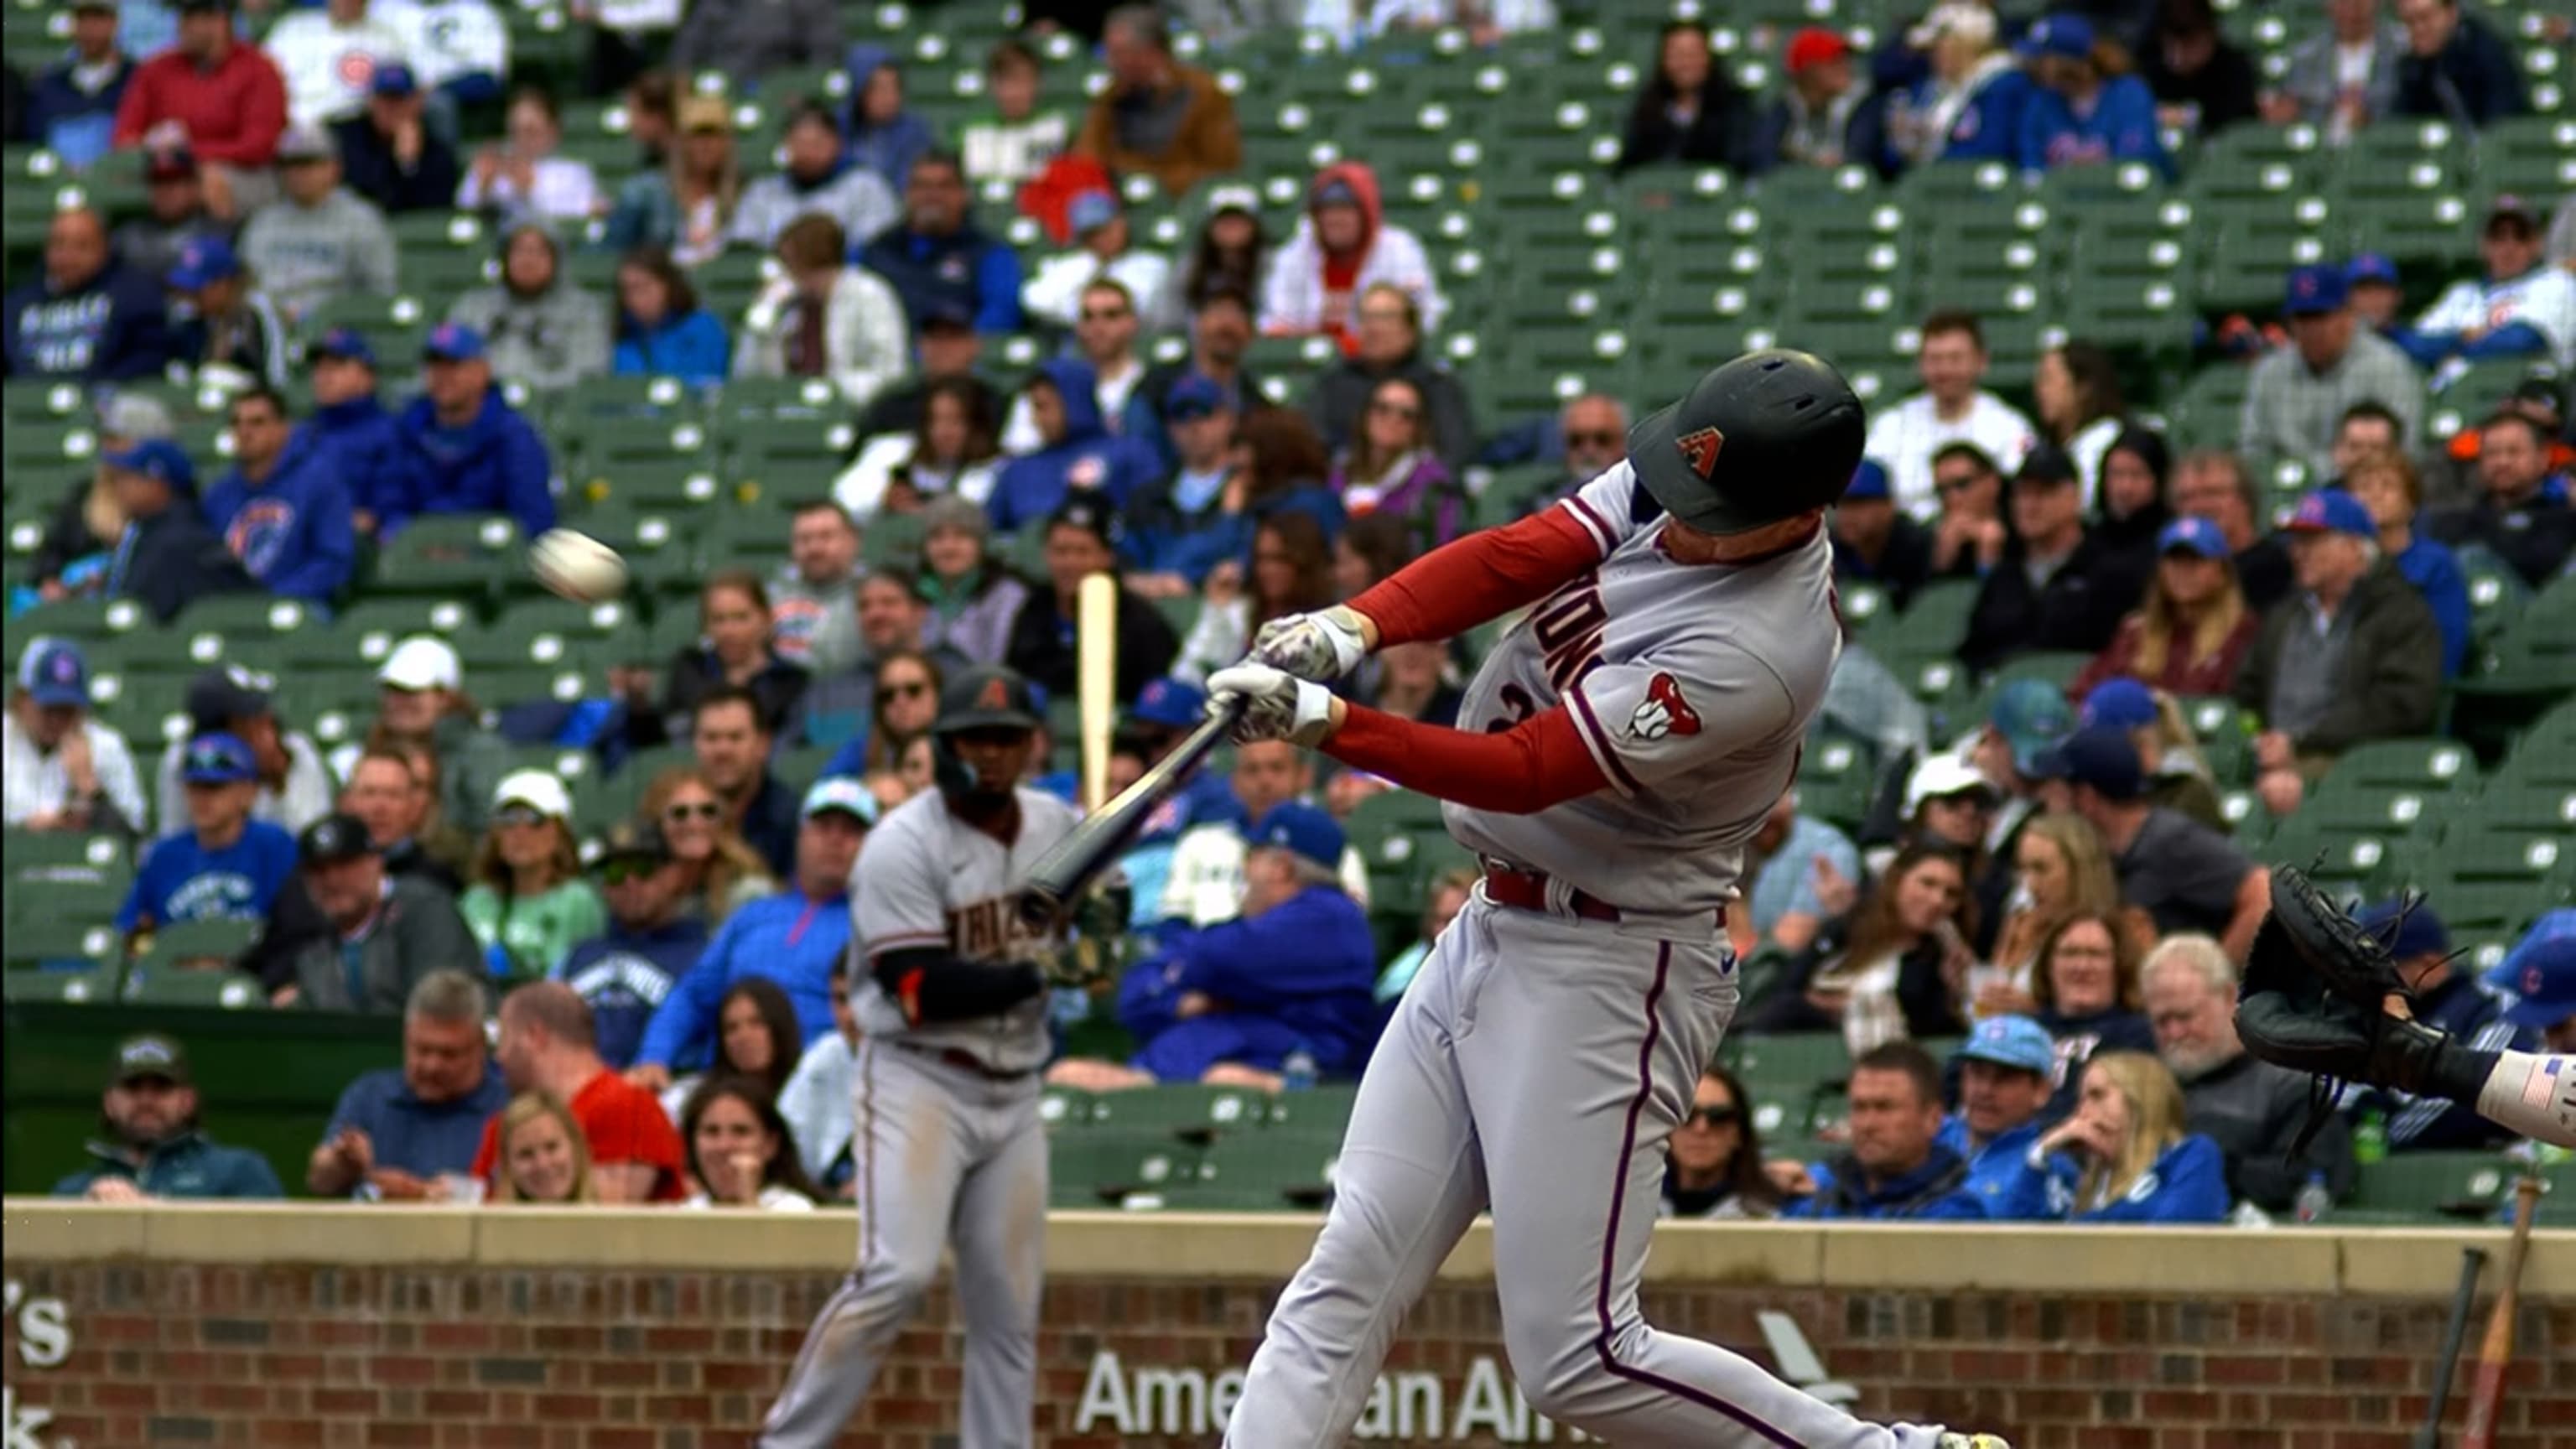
(2236, 487, 2442, 815)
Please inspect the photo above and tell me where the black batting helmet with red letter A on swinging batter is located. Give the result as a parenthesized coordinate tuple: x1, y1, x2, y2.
(1628, 348, 1867, 533)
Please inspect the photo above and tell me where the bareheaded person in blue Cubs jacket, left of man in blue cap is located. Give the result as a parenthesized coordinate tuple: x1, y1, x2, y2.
(206, 387, 358, 603)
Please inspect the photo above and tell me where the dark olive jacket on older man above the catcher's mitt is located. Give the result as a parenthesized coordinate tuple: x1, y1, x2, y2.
(2236, 559, 2442, 756)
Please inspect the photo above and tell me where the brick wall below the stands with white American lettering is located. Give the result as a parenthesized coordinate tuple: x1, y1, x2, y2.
(0, 1219, 2576, 1449)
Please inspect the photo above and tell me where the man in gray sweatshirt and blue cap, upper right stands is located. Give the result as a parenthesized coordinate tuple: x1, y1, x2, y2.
(2236, 263, 2424, 482)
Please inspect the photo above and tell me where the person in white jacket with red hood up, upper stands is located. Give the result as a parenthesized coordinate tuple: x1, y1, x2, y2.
(1262, 160, 1447, 353)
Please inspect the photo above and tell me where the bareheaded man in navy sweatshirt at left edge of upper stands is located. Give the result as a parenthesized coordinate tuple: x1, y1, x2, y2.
(0, 206, 170, 382)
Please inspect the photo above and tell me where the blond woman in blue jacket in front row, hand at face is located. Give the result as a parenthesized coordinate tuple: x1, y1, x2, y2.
(2007, 1052, 2228, 1222)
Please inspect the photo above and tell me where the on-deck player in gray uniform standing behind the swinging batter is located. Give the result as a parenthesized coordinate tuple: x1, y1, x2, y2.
(760, 667, 1074, 1449)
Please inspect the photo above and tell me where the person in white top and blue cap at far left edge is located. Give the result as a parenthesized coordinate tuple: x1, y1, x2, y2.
(0, 634, 149, 835)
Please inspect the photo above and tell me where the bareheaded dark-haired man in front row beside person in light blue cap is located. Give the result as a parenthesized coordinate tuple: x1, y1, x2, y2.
(1775, 1041, 1987, 1222)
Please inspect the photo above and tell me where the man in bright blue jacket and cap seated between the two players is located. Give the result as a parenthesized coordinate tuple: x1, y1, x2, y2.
(1071, 799, 1379, 1091)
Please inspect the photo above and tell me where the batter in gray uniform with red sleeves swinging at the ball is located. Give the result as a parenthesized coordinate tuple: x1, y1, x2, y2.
(1208, 351, 1999, 1449)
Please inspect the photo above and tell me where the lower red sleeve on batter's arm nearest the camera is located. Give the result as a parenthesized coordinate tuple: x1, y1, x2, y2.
(1324, 701, 1610, 815)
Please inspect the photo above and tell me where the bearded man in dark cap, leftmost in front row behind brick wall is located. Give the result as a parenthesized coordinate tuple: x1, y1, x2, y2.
(55, 1031, 286, 1202)
